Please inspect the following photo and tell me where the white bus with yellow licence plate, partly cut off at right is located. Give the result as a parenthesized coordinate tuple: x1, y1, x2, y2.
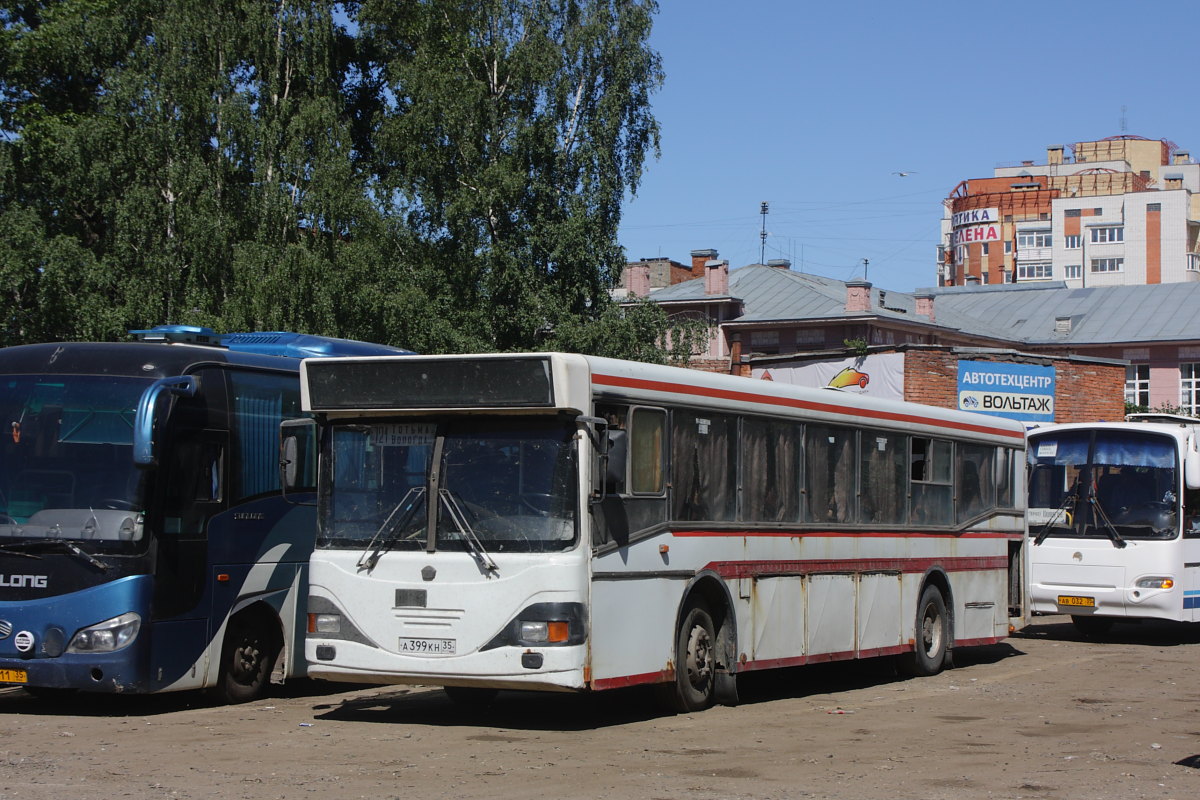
(1028, 415, 1200, 634)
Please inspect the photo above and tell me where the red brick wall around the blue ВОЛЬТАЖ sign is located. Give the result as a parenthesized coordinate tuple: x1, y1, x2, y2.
(904, 350, 1124, 422)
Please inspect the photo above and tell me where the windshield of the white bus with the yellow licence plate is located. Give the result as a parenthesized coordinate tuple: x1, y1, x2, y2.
(1028, 429, 1180, 543)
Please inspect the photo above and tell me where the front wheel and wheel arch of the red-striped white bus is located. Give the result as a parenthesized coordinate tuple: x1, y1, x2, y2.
(658, 573, 738, 712)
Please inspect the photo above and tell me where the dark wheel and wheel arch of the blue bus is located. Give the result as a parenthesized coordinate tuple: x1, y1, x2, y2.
(209, 602, 283, 703)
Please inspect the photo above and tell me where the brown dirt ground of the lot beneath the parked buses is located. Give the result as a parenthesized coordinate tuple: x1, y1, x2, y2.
(0, 616, 1200, 800)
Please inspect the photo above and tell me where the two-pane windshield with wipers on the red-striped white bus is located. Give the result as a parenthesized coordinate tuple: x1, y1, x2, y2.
(317, 416, 577, 553)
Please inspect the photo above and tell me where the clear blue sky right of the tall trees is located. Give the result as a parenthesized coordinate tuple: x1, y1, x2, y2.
(620, 0, 1200, 291)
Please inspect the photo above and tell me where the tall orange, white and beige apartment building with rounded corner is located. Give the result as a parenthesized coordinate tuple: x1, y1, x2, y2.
(938, 136, 1200, 288)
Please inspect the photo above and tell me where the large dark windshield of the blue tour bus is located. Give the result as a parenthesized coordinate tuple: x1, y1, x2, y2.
(0, 375, 148, 546)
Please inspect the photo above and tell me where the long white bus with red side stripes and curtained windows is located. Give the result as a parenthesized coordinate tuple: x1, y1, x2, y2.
(292, 354, 1025, 710)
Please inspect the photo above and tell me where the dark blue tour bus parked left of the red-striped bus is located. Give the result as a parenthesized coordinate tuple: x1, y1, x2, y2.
(0, 325, 408, 702)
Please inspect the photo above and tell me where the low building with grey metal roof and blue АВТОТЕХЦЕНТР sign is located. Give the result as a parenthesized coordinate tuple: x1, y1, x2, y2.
(624, 251, 1200, 422)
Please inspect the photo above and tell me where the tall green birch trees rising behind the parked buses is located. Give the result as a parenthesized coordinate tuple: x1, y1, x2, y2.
(0, 0, 667, 360)
